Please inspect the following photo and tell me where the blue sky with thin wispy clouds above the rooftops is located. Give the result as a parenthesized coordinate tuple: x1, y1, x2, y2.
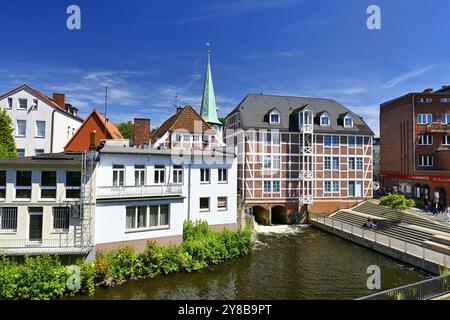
(0, 0, 450, 133)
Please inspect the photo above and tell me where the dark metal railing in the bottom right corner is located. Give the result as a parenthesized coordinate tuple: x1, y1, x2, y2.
(356, 275, 450, 300)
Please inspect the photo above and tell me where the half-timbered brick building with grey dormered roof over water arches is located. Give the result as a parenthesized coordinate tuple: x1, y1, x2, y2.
(225, 94, 373, 222)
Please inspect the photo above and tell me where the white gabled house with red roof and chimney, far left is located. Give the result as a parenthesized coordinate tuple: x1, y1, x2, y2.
(0, 85, 83, 157)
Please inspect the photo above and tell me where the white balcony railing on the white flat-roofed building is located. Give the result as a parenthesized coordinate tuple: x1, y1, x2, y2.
(97, 185, 182, 199)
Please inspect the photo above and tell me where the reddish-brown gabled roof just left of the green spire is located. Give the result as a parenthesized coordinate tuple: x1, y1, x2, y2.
(152, 106, 214, 141)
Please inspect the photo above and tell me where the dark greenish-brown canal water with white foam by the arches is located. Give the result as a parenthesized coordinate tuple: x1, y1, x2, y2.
(80, 226, 429, 299)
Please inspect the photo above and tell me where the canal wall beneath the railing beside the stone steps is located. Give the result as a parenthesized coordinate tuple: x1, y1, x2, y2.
(309, 219, 441, 275)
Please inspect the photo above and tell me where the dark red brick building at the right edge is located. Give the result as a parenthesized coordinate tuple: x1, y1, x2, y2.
(380, 86, 450, 205)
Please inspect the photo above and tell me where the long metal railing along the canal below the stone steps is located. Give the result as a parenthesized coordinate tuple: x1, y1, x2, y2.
(310, 214, 450, 268)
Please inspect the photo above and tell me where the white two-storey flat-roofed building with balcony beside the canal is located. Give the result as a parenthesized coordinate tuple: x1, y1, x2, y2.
(95, 140, 237, 251)
